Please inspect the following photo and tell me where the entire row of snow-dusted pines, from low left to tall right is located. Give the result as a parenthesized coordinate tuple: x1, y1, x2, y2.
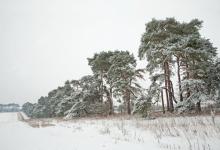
(22, 18, 220, 118)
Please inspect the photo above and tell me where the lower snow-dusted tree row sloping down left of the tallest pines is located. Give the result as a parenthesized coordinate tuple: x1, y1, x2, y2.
(22, 51, 143, 118)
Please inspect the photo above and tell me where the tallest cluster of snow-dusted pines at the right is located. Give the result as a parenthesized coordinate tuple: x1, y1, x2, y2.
(139, 18, 220, 112)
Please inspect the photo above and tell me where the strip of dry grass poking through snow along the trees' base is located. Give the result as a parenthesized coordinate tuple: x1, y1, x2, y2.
(18, 111, 220, 150)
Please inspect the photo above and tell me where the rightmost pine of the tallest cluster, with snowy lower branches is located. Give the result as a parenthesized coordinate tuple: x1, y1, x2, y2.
(182, 34, 217, 112)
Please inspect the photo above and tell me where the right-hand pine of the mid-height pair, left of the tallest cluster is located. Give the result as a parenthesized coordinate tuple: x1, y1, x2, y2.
(107, 51, 143, 114)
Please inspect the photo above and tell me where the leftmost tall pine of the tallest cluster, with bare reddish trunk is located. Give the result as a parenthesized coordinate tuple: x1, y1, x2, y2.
(139, 18, 178, 112)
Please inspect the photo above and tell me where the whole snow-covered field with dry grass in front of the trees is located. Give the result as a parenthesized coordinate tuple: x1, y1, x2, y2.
(0, 113, 220, 150)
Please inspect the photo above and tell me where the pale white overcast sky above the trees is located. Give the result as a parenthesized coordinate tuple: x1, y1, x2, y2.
(0, 0, 220, 104)
